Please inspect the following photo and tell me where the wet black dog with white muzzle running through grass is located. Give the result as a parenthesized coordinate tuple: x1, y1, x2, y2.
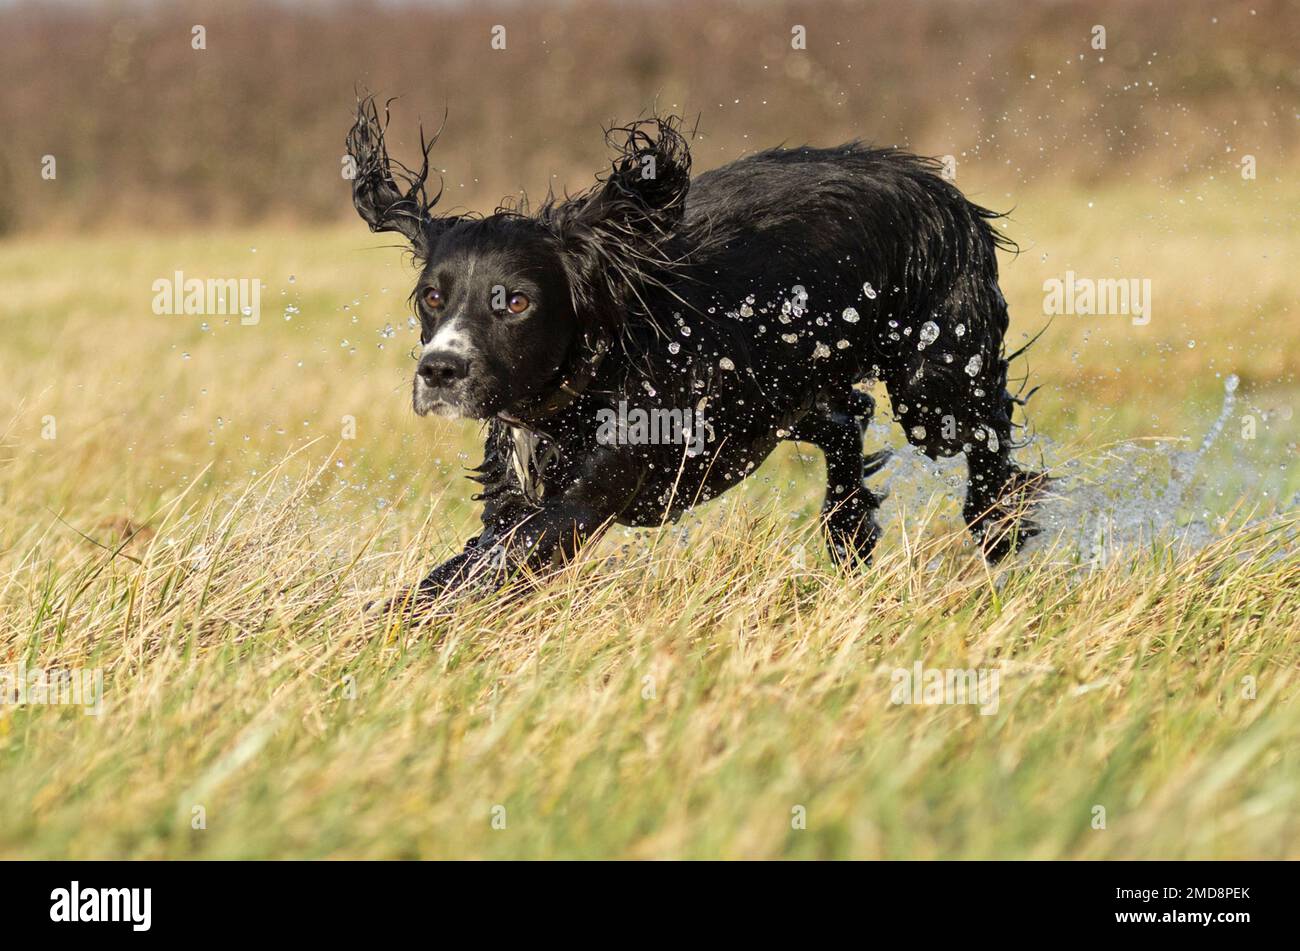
(347, 92, 1041, 600)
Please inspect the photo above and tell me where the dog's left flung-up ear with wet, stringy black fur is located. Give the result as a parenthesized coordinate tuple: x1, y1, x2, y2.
(346, 96, 456, 259)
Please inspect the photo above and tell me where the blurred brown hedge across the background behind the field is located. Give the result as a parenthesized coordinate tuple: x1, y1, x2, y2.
(0, 0, 1300, 231)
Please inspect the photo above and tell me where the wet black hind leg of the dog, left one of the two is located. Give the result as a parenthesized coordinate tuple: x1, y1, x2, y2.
(789, 390, 889, 565)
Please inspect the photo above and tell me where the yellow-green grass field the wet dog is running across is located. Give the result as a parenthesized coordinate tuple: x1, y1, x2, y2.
(0, 174, 1300, 857)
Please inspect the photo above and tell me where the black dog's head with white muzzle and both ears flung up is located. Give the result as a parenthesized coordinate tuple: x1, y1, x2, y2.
(347, 99, 690, 418)
